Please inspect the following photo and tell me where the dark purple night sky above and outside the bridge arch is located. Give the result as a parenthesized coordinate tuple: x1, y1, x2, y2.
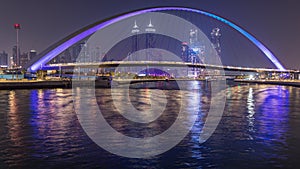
(0, 0, 300, 69)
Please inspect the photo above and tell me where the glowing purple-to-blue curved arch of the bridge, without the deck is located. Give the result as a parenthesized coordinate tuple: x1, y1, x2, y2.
(29, 7, 286, 72)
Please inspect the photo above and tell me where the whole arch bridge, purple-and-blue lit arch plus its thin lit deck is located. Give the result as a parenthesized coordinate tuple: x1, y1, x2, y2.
(25, 7, 287, 73)
